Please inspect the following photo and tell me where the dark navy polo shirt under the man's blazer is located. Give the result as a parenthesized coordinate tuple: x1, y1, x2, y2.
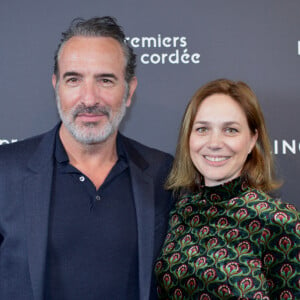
(45, 133, 139, 300)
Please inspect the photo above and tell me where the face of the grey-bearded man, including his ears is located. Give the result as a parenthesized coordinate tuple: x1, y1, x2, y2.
(52, 37, 137, 144)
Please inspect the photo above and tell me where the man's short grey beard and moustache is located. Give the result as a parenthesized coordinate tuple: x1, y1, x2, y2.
(56, 91, 128, 145)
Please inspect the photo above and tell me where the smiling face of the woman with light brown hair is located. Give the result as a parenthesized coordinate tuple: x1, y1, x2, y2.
(190, 94, 257, 186)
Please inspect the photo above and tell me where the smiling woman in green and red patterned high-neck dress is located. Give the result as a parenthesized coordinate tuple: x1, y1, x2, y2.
(155, 79, 300, 300)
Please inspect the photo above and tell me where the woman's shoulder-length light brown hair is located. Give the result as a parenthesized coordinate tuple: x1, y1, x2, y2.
(165, 79, 280, 193)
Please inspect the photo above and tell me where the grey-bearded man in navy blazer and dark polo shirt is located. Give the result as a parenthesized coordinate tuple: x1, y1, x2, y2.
(0, 17, 172, 300)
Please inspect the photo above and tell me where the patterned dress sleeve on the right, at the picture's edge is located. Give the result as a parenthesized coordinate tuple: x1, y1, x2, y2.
(261, 200, 300, 299)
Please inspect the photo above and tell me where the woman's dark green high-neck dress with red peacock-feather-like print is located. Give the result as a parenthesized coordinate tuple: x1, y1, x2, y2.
(155, 178, 300, 300)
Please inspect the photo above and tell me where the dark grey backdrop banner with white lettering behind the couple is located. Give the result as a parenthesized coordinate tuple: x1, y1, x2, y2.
(0, 0, 300, 208)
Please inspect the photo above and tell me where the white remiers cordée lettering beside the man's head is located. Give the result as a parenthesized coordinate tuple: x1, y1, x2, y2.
(126, 34, 200, 65)
